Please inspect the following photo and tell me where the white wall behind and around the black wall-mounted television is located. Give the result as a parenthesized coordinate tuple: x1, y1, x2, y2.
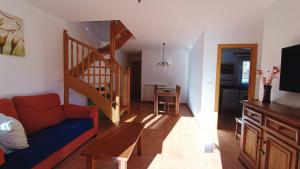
(260, 0, 300, 107)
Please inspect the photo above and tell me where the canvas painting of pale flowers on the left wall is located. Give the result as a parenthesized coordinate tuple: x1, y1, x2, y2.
(0, 10, 25, 56)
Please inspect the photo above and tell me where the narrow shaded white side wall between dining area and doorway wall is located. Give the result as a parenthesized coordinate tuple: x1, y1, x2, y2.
(188, 34, 204, 114)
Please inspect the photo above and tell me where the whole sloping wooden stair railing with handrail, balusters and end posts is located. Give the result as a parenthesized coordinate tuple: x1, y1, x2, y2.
(64, 30, 130, 123)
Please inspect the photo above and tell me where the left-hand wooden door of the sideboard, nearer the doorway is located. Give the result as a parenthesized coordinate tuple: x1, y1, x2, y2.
(241, 120, 261, 168)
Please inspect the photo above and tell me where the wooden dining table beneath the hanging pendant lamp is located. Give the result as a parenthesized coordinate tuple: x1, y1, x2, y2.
(154, 88, 179, 116)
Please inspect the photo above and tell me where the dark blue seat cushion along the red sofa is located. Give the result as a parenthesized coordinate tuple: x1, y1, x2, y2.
(0, 119, 93, 169)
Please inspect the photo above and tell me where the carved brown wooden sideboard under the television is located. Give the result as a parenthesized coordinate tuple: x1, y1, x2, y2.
(238, 101, 300, 169)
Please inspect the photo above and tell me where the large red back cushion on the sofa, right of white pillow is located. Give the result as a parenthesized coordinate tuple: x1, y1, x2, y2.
(13, 93, 65, 134)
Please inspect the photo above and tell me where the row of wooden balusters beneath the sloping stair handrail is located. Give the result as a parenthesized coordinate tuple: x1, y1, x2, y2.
(65, 32, 111, 99)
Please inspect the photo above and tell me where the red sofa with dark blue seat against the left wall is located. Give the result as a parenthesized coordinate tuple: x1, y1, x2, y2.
(0, 93, 98, 169)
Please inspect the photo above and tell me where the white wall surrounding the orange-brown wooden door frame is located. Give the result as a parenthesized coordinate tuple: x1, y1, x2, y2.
(201, 29, 263, 112)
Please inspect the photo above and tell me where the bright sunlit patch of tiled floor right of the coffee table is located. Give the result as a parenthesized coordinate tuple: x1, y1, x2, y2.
(141, 116, 222, 169)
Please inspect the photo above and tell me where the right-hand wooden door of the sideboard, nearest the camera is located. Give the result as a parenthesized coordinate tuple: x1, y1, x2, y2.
(261, 133, 297, 169)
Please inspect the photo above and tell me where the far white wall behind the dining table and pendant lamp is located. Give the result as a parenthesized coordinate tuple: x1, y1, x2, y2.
(141, 50, 188, 102)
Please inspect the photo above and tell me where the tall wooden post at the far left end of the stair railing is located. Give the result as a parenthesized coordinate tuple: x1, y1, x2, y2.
(63, 30, 69, 104)
